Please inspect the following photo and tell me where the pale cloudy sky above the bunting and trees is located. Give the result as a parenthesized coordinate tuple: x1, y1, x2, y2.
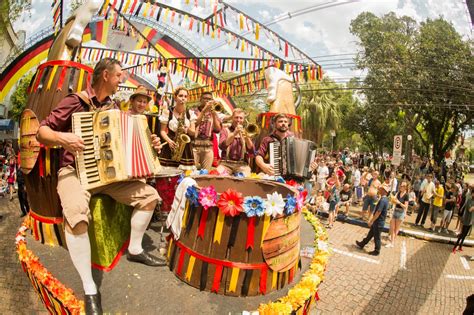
(15, 0, 473, 79)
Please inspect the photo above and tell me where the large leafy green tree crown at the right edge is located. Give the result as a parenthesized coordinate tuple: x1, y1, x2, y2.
(351, 12, 474, 162)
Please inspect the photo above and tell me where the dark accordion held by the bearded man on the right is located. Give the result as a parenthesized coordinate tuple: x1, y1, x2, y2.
(268, 137, 316, 180)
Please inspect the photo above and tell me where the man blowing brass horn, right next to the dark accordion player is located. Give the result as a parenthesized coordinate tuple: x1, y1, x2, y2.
(217, 108, 255, 176)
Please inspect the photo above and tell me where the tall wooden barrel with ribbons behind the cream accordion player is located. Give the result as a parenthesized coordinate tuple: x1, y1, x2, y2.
(20, 60, 93, 246)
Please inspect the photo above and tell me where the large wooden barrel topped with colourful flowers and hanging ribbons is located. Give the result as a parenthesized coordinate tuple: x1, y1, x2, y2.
(168, 176, 304, 296)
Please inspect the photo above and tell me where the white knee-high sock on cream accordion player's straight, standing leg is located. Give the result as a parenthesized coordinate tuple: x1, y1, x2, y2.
(65, 231, 97, 295)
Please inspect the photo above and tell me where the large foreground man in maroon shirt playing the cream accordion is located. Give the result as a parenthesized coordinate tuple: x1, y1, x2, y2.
(37, 58, 166, 314)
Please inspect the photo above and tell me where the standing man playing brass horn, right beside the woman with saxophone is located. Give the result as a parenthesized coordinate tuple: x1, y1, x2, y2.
(193, 92, 221, 170)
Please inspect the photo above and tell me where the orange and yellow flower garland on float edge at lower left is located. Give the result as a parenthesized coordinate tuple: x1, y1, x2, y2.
(15, 216, 84, 314)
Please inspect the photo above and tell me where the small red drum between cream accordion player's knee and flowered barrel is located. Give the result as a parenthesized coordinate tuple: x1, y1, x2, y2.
(155, 167, 183, 213)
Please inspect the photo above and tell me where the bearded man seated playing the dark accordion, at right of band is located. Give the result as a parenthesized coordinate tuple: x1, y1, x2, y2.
(255, 114, 293, 175)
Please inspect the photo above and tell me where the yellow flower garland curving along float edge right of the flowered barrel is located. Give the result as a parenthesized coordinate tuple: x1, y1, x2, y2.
(258, 207, 329, 315)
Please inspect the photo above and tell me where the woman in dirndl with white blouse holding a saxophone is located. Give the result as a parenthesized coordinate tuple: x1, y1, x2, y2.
(160, 87, 196, 170)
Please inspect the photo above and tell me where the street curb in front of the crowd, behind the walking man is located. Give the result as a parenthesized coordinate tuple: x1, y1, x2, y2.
(318, 212, 474, 247)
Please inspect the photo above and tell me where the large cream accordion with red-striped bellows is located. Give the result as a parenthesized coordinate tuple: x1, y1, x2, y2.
(72, 109, 161, 189)
